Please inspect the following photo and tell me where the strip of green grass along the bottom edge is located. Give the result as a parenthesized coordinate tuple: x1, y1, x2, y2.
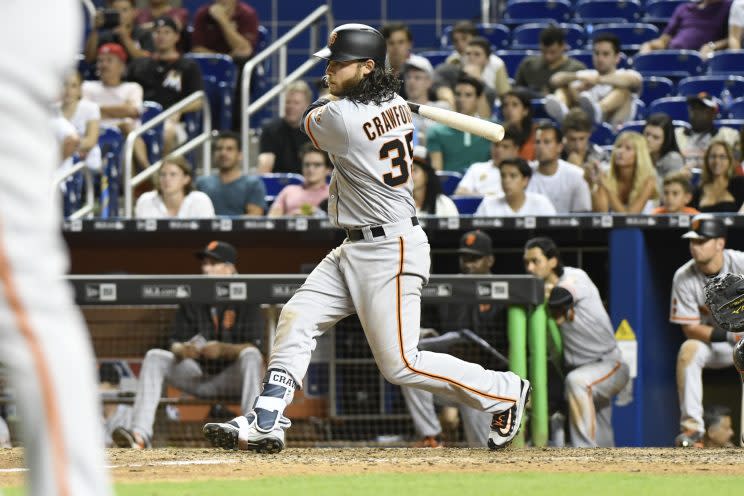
(4, 472, 742, 496)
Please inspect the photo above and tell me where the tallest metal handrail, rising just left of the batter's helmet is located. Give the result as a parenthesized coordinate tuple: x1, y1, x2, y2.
(240, 5, 333, 174)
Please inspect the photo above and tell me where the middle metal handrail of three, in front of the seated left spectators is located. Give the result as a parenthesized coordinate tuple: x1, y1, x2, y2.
(124, 90, 212, 218)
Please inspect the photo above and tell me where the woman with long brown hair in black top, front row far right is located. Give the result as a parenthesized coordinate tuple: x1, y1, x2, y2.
(692, 141, 744, 212)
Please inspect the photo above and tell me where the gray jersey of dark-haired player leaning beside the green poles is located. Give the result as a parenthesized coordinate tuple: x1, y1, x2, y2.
(558, 267, 620, 367)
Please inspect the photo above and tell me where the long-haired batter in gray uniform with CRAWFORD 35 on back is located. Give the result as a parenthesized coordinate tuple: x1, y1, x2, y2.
(204, 24, 530, 453)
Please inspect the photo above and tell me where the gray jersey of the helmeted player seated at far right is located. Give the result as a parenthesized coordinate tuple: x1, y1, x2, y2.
(669, 250, 744, 325)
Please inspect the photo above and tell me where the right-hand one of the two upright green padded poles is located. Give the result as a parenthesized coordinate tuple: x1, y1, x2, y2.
(527, 305, 548, 447)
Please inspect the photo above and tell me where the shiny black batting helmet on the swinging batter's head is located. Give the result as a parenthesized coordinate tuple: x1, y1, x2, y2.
(313, 24, 387, 68)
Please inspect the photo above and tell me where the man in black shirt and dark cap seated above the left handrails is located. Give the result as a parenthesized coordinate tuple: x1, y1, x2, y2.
(128, 16, 204, 153)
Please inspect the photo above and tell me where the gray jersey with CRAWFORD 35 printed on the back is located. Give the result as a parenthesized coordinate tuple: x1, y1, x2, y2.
(302, 95, 416, 228)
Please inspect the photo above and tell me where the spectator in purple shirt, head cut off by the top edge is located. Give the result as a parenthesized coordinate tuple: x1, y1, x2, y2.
(639, 0, 731, 57)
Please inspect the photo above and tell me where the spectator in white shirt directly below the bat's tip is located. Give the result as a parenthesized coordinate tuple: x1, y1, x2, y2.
(455, 126, 522, 196)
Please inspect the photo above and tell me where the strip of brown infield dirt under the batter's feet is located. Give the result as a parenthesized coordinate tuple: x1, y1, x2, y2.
(0, 448, 744, 487)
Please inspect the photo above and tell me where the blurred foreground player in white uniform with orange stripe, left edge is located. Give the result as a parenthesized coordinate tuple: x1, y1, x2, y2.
(0, 0, 111, 496)
